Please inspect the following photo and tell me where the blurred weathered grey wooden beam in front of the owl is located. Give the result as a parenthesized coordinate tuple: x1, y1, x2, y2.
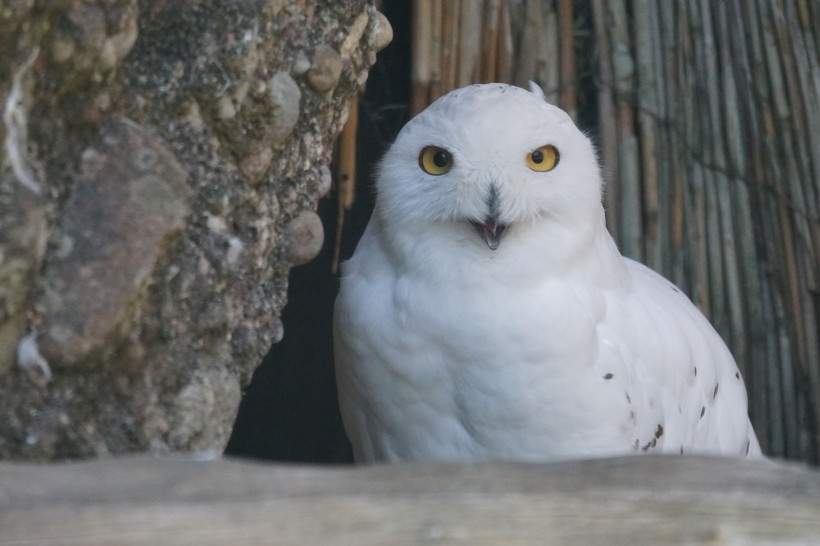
(0, 456, 820, 546)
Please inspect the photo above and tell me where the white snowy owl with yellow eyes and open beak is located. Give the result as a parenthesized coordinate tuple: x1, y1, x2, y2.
(334, 84, 760, 462)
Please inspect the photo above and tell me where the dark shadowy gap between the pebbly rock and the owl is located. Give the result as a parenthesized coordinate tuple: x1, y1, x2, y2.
(226, 1, 411, 463)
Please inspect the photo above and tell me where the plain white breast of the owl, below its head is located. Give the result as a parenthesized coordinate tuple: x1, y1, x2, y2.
(337, 238, 632, 460)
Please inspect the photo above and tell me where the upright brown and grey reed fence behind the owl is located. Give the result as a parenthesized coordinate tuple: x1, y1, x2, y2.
(336, 0, 820, 463)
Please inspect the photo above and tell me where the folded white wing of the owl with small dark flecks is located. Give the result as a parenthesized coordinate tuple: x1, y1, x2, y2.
(598, 260, 760, 456)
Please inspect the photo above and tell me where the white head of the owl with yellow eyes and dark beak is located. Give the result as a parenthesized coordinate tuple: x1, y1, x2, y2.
(377, 84, 601, 250)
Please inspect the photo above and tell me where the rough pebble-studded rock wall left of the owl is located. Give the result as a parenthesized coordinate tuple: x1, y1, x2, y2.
(0, 0, 391, 460)
